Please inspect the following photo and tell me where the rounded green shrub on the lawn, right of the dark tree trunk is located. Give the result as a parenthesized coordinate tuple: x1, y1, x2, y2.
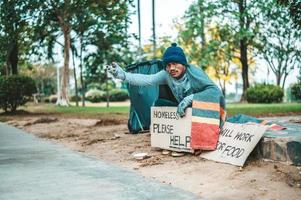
(246, 84, 284, 103)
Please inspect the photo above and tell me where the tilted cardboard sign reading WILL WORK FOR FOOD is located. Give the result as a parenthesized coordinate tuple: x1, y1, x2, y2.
(201, 122, 268, 166)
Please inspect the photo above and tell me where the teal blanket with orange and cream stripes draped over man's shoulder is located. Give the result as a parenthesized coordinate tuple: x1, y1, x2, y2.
(186, 65, 226, 150)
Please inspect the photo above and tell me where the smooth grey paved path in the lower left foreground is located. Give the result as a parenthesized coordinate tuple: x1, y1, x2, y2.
(0, 123, 198, 200)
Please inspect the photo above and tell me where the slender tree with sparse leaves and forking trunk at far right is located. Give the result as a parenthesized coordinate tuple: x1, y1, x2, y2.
(259, 0, 301, 88)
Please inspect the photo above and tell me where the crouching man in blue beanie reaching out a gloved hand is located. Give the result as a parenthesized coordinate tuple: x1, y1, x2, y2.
(108, 43, 225, 156)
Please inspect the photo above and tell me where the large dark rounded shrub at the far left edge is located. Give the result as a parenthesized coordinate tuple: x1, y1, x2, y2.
(0, 75, 36, 112)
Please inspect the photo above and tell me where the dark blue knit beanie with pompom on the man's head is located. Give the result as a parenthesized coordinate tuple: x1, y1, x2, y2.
(162, 43, 188, 66)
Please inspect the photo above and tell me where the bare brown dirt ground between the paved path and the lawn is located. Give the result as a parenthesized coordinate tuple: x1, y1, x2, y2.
(0, 104, 301, 200)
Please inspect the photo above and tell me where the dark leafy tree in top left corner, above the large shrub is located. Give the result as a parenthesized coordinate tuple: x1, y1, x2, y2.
(0, 0, 32, 75)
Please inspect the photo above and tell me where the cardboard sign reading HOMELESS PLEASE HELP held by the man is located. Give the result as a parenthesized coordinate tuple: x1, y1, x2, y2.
(150, 107, 193, 152)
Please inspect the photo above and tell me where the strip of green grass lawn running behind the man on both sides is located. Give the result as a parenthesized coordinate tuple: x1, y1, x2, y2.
(0, 103, 301, 119)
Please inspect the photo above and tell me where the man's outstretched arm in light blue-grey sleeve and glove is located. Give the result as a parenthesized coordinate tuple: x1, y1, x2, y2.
(107, 63, 167, 86)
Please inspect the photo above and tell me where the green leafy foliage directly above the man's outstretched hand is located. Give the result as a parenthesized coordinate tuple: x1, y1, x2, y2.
(79, 0, 133, 83)
